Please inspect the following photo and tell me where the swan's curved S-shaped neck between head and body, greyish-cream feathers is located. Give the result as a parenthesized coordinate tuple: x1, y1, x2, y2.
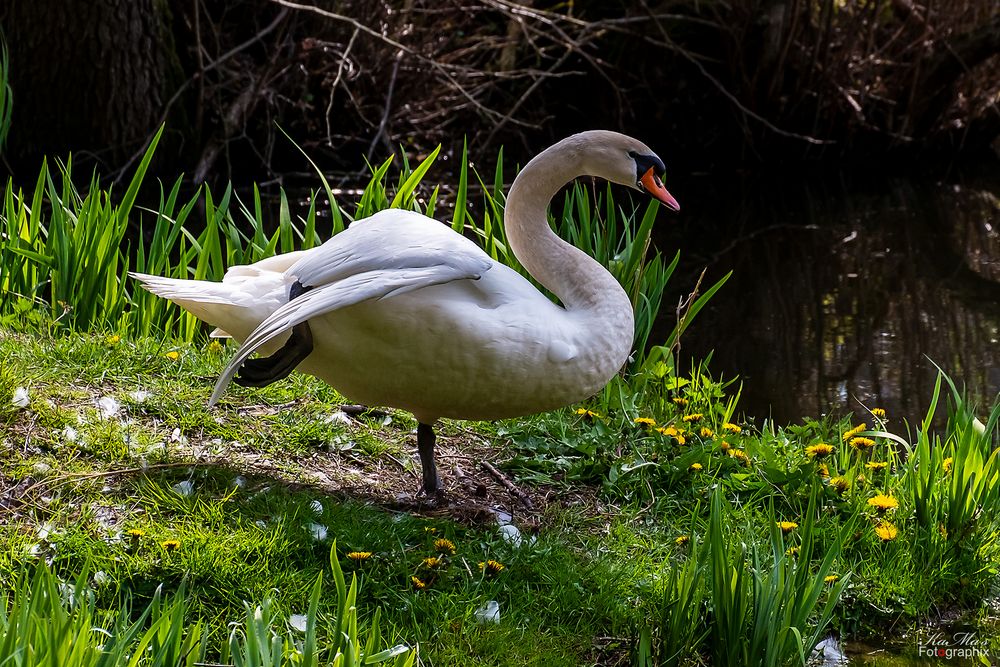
(504, 140, 632, 318)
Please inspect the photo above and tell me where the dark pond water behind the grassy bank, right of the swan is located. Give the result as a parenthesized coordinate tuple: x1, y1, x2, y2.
(656, 163, 1000, 427)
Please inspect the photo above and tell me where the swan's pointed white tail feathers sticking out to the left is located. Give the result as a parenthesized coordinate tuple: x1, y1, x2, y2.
(129, 273, 287, 341)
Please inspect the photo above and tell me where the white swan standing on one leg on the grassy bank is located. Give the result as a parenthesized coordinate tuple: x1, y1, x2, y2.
(132, 131, 680, 493)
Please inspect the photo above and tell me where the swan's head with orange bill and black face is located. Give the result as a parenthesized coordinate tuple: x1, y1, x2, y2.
(566, 130, 681, 211)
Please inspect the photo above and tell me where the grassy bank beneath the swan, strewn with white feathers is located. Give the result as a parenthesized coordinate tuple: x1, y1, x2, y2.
(0, 331, 998, 667)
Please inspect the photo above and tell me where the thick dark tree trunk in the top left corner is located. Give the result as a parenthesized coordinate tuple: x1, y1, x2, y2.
(0, 0, 180, 176)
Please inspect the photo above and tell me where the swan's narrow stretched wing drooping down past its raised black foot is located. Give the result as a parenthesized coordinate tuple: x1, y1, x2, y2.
(208, 255, 492, 407)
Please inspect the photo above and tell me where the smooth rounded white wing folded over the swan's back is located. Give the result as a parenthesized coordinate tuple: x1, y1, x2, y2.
(285, 209, 492, 288)
